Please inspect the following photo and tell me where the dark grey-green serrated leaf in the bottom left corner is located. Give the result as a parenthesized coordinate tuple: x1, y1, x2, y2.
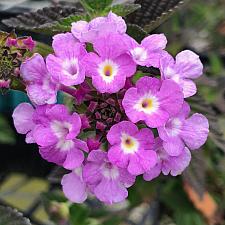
(0, 206, 31, 225)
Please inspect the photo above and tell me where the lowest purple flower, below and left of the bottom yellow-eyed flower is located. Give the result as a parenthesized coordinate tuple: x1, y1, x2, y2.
(83, 150, 135, 204)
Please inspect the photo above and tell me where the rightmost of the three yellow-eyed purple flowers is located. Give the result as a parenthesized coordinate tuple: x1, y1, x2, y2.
(122, 77, 183, 128)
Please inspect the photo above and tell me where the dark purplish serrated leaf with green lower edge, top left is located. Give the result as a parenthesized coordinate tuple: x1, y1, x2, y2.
(2, 4, 83, 34)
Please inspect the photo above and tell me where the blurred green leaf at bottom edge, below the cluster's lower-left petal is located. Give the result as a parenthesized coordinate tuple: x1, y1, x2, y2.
(70, 204, 89, 225)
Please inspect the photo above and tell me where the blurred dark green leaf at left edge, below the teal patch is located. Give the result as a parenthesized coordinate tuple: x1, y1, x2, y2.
(0, 115, 16, 145)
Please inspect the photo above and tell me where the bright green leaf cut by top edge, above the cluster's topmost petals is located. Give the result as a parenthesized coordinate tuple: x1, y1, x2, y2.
(80, 0, 113, 13)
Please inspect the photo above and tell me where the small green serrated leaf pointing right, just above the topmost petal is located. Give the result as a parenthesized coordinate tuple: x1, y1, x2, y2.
(105, 4, 141, 17)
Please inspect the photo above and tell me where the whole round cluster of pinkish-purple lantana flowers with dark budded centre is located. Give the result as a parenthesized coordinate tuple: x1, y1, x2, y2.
(13, 12, 209, 204)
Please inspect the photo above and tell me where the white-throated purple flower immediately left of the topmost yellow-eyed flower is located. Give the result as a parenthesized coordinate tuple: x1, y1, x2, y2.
(46, 33, 86, 86)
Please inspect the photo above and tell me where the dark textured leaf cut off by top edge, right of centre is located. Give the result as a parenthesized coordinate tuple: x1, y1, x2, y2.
(128, 0, 184, 32)
